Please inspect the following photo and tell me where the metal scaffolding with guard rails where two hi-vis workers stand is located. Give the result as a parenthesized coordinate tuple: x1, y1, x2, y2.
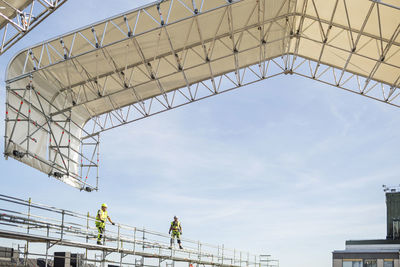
(0, 195, 276, 267)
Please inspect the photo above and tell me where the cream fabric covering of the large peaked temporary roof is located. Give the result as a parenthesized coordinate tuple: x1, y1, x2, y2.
(6, 0, 400, 189)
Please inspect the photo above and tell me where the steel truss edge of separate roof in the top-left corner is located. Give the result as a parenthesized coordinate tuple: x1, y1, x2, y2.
(0, 0, 67, 55)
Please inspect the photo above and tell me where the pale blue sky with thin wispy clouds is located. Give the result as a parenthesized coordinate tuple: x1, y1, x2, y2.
(0, 0, 400, 267)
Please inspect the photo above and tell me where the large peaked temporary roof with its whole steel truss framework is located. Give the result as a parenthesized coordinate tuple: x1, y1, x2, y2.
(5, 0, 400, 193)
